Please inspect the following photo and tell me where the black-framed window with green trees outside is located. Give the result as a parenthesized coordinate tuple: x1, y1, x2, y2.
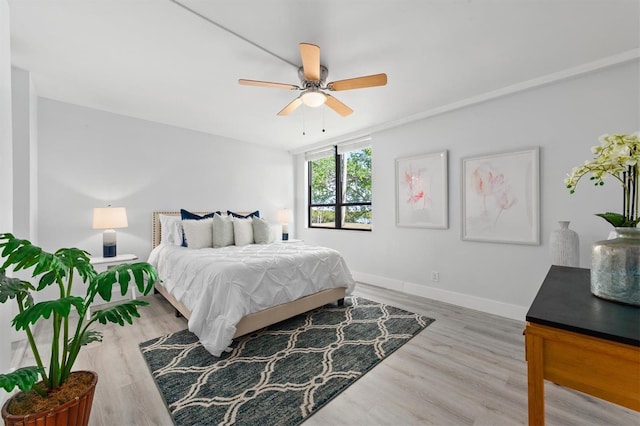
(307, 144, 371, 231)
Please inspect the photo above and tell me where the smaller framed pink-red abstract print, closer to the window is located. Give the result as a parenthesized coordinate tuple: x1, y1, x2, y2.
(396, 151, 449, 228)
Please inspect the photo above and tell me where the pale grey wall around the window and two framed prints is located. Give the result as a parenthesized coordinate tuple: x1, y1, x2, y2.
(296, 61, 640, 320)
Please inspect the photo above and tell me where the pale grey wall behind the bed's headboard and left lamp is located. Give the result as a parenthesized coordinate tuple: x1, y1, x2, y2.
(38, 98, 293, 260)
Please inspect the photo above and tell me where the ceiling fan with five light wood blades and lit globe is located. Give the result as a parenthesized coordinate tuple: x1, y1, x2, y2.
(238, 43, 387, 117)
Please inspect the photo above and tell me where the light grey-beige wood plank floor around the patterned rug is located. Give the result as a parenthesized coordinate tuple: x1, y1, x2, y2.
(13, 284, 640, 426)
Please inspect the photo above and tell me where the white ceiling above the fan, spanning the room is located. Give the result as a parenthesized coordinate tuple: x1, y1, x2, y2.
(9, 0, 640, 151)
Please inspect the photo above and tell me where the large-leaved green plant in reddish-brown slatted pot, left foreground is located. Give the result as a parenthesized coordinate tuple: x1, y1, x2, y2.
(0, 233, 157, 426)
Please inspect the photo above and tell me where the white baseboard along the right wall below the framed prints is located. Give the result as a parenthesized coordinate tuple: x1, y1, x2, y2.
(352, 271, 528, 322)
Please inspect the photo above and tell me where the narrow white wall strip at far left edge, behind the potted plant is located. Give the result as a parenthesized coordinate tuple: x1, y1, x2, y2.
(0, 0, 13, 404)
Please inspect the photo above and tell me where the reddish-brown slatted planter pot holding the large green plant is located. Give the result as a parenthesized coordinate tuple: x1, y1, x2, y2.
(2, 371, 98, 426)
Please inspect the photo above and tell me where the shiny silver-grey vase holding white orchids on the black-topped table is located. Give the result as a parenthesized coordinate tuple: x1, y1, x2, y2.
(591, 228, 640, 306)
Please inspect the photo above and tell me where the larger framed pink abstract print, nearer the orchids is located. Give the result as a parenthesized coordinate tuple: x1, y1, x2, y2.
(462, 148, 540, 244)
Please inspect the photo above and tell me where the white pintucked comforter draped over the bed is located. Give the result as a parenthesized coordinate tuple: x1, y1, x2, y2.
(149, 243, 355, 356)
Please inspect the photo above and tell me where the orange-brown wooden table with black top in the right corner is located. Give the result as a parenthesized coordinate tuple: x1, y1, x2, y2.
(525, 266, 640, 425)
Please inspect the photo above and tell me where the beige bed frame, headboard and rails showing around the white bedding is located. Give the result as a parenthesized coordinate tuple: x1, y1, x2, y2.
(151, 211, 346, 338)
